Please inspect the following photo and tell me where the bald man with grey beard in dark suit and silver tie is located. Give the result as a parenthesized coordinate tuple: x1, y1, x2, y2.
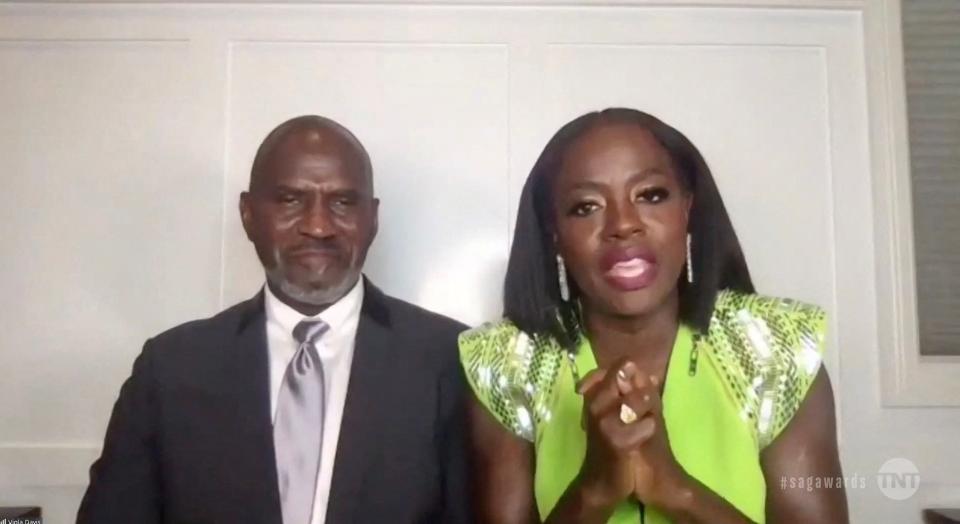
(77, 116, 469, 524)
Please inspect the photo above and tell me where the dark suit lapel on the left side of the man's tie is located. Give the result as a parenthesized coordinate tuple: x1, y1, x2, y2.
(226, 291, 282, 524)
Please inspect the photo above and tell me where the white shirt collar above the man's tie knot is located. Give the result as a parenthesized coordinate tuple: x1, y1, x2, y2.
(263, 277, 364, 341)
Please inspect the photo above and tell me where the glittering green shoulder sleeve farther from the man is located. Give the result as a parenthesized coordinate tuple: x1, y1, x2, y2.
(703, 291, 826, 449)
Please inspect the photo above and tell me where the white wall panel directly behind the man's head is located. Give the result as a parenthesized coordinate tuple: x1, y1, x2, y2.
(224, 42, 509, 324)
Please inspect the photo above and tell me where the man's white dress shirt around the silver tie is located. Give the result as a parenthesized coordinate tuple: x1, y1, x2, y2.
(264, 279, 363, 524)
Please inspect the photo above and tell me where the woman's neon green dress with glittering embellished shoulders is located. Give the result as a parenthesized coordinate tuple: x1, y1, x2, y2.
(460, 291, 825, 524)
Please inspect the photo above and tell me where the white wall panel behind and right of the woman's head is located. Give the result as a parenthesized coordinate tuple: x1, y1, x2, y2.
(546, 44, 833, 314)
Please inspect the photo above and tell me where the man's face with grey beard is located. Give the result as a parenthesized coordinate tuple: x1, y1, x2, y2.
(240, 130, 379, 307)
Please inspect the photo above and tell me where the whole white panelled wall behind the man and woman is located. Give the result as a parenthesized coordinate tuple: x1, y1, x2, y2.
(0, 1, 960, 523)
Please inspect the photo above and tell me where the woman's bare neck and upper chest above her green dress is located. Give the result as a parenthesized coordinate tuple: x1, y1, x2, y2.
(583, 293, 680, 370)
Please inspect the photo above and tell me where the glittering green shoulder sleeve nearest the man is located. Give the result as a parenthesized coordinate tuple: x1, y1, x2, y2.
(459, 320, 564, 442)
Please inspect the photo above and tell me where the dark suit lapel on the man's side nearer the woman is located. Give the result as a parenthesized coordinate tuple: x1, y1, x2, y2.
(327, 281, 396, 523)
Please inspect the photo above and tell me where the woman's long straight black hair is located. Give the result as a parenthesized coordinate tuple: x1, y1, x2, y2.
(503, 108, 754, 348)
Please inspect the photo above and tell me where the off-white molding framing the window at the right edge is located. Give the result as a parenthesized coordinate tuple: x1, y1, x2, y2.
(864, 0, 960, 407)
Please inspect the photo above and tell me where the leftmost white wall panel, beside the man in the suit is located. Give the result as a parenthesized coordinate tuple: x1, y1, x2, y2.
(0, 41, 222, 443)
